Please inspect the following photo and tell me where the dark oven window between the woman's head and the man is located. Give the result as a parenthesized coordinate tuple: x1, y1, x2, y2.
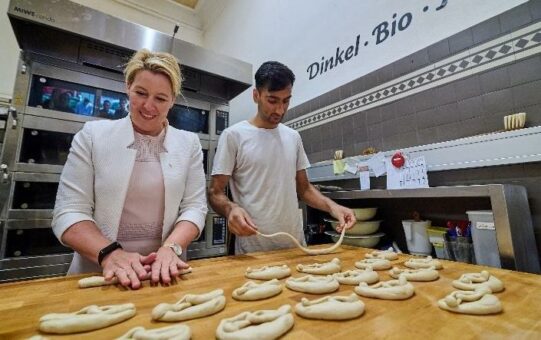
(167, 105, 209, 134)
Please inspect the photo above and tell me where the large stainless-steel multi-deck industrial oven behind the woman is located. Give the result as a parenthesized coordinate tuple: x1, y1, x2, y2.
(0, 0, 252, 281)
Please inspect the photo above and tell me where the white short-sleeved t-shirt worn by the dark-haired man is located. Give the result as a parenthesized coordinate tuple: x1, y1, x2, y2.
(212, 121, 310, 254)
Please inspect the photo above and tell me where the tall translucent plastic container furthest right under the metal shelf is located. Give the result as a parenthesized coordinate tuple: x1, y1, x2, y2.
(466, 210, 502, 268)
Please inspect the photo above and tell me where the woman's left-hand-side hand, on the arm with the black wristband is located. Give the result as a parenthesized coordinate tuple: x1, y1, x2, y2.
(102, 249, 156, 289)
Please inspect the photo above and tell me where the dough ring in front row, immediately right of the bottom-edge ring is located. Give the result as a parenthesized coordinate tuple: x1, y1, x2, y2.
(295, 294, 364, 320)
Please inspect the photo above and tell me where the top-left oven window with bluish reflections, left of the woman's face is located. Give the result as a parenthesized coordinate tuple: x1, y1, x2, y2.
(28, 75, 96, 116)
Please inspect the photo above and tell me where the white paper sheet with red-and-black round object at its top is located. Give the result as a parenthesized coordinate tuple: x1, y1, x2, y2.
(385, 156, 428, 189)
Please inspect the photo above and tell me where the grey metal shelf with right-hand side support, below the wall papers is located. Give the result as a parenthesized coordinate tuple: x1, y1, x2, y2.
(325, 184, 541, 273)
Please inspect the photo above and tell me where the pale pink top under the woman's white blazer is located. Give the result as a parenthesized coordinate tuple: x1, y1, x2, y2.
(117, 129, 166, 255)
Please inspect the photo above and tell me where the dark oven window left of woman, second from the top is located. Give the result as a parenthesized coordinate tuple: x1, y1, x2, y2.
(19, 129, 74, 165)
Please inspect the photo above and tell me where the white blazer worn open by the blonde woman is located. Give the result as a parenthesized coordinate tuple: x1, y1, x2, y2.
(52, 116, 208, 265)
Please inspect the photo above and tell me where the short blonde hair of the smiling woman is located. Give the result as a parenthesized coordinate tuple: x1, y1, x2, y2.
(124, 48, 183, 97)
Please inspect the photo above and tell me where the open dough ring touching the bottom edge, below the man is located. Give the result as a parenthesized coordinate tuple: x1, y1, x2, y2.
(216, 305, 294, 340)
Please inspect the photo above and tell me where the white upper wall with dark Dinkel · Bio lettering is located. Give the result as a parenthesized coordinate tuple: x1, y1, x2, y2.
(204, 0, 526, 123)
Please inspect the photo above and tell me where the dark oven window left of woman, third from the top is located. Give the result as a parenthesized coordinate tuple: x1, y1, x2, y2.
(11, 181, 58, 209)
